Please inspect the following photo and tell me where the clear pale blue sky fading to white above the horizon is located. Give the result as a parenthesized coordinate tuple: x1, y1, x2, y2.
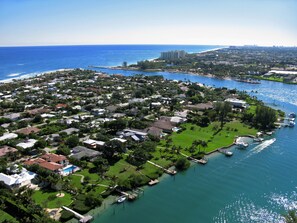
(0, 0, 297, 46)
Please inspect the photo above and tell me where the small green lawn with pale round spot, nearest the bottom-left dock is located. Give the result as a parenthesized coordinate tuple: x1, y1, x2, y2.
(32, 190, 72, 208)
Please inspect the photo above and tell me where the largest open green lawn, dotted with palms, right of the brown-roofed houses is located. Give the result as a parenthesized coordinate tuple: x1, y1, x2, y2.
(171, 121, 257, 154)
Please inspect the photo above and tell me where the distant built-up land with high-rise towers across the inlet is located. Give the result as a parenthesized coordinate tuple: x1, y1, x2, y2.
(115, 46, 297, 84)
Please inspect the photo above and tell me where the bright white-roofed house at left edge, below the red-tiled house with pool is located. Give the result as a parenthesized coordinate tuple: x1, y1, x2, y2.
(0, 168, 36, 189)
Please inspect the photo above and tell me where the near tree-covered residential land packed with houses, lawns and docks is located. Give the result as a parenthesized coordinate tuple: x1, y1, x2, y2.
(0, 69, 284, 223)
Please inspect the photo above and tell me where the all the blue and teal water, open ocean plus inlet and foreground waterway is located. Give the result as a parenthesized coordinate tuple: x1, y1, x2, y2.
(0, 45, 297, 223)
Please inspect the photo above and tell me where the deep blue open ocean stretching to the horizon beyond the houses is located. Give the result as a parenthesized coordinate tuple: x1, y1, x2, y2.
(0, 45, 220, 80)
